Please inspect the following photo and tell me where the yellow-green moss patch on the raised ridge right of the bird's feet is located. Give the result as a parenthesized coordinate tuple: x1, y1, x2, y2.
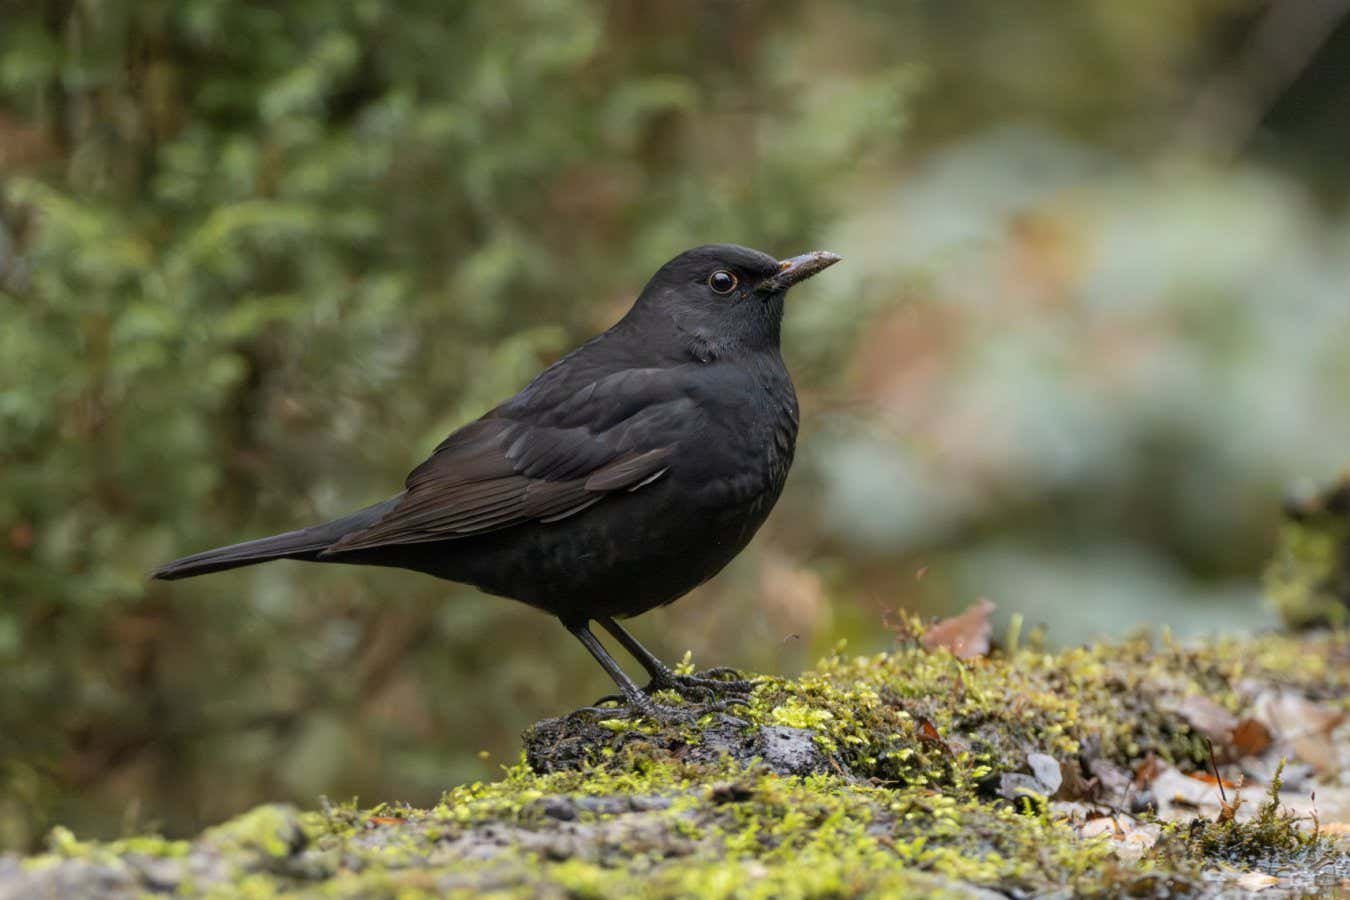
(718, 634, 1347, 788)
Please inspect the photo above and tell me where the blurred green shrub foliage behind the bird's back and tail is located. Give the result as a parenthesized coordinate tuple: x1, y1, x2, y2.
(0, 0, 907, 846)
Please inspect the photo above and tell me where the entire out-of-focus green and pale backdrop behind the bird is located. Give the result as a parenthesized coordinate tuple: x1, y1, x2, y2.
(0, 0, 1350, 849)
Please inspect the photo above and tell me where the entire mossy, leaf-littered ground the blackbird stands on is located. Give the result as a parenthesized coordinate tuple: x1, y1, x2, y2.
(0, 626, 1350, 897)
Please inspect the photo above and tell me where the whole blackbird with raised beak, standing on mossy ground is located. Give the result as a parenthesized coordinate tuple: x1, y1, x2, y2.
(154, 244, 840, 716)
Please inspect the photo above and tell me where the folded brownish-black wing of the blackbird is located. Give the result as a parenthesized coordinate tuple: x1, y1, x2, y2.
(324, 370, 694, 555)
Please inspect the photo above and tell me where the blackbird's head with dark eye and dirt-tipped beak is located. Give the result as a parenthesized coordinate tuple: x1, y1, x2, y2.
(633, 244, 840, 359)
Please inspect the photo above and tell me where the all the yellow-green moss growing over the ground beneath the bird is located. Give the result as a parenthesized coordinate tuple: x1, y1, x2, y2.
(5, 634, 1350, 897)
